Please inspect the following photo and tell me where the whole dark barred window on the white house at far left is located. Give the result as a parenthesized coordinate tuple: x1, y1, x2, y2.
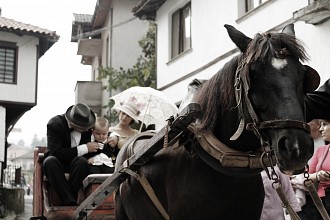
(0, 42, 17, 84)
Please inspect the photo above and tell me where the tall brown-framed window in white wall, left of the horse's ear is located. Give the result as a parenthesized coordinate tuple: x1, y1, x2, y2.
(171, 3, 191, 58)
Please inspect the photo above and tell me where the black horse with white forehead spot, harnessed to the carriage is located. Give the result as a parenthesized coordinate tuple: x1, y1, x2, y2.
(116, 24, 319, 220)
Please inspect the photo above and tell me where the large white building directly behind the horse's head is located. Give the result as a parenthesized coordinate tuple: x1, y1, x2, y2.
(134, 0, 330, 103)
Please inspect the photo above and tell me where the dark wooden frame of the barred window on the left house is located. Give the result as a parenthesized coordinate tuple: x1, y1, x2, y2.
(0, 41, 18, 84)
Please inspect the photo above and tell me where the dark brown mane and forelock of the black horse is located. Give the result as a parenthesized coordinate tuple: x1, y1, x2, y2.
(195, 32, 308, 130)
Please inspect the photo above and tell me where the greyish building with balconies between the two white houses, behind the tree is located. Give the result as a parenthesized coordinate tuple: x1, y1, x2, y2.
(71, 0, 149, 116)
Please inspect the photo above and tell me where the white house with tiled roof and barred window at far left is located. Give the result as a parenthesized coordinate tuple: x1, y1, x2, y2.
(0, 16, 59, 177)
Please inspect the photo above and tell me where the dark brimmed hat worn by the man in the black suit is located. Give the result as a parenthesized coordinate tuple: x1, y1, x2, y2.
(65, 103, 95, 129)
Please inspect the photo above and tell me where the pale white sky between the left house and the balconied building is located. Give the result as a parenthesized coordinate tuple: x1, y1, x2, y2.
(0, 0, 97, 146)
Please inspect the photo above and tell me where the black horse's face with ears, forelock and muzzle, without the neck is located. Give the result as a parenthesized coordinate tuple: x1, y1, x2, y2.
(225, 24, 320, 174)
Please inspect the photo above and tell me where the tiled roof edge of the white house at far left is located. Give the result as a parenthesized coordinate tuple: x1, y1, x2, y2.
(0, 17, 59, 41)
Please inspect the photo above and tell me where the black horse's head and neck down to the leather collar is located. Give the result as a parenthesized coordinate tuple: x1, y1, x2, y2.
(196, 24, 320, 174)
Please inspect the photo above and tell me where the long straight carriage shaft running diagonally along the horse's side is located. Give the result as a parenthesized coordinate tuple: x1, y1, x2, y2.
(73, 103, 200, 219)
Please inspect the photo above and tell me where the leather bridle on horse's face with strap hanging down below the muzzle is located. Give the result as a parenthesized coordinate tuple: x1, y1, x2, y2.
(230, 58, 310, 219)
